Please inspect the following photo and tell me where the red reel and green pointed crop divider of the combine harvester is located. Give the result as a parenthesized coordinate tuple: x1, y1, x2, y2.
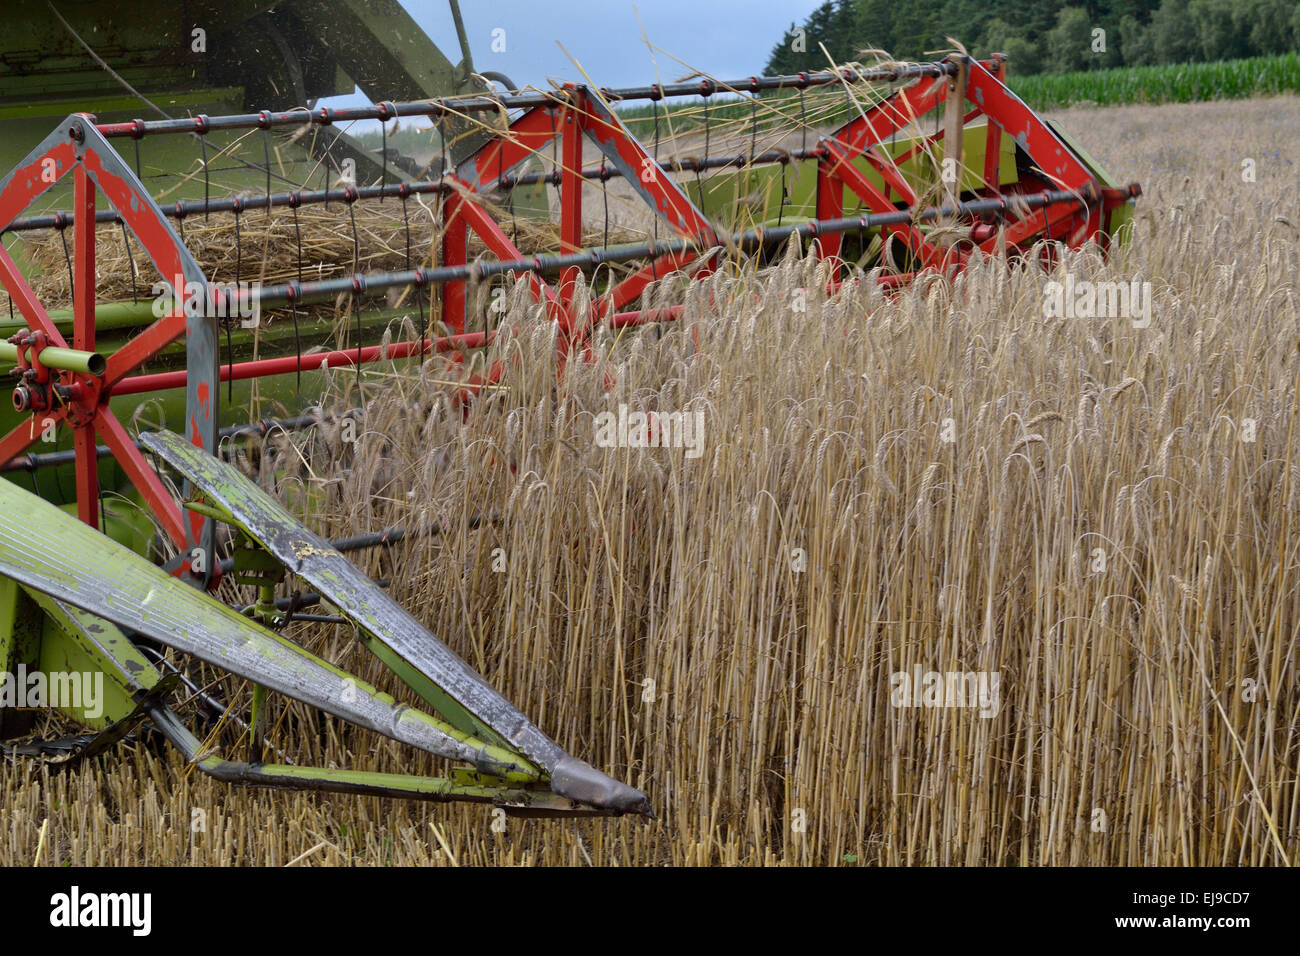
(0, 1, 1139, 814)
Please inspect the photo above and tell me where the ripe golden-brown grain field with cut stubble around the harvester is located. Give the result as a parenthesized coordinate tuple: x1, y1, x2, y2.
(0, 96, 1300, 866)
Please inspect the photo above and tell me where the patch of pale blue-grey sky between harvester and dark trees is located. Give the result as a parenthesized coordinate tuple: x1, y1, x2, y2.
(321, 0, 822, 113)
